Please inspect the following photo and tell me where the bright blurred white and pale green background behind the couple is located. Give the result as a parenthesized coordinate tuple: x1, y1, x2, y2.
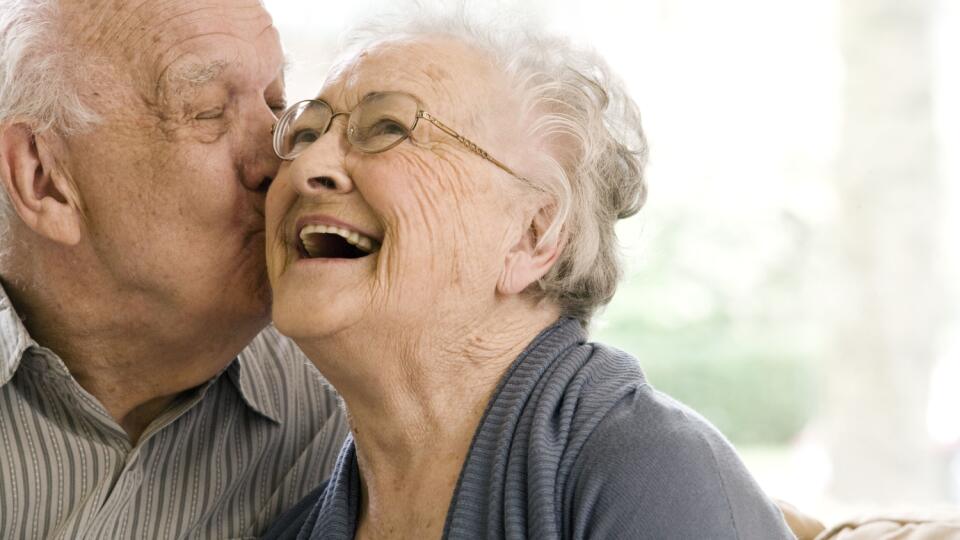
(265, 0, 960, 524)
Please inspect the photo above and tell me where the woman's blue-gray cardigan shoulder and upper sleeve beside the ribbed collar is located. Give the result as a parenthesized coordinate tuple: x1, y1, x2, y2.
(565, 344, 790, 538)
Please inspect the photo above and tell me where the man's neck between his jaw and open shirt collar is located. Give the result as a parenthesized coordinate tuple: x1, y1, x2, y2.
(3, 264, 267, 444)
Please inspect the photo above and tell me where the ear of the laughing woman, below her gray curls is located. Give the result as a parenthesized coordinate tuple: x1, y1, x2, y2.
(497, 204, 566, 294)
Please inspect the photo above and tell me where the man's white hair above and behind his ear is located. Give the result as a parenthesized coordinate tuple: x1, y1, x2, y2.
(0, 0, 97, 259)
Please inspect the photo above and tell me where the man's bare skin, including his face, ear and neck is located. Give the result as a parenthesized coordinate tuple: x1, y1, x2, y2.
(2, 0, 284, 441)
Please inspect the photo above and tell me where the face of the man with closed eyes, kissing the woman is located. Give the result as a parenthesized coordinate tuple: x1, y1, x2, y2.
(61, 0, 284, 331)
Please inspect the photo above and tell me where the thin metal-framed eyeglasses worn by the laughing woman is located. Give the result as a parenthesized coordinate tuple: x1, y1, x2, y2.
(273, 92, 522, 180)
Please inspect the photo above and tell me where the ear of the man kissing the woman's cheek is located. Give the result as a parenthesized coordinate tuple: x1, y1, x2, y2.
(0, 124, 83, 246)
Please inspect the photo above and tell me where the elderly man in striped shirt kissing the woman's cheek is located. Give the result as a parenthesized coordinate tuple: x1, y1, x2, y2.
(0, 0, 346, 538)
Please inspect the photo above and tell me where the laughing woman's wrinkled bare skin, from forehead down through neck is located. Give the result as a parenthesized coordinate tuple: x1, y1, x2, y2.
(267, 36, 559, 538)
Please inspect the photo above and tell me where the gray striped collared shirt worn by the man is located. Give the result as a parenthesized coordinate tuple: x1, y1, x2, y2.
(0, 288, 348, 540)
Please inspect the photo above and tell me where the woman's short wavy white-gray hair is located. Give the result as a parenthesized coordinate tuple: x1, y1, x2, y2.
(344, 9, 647, 326)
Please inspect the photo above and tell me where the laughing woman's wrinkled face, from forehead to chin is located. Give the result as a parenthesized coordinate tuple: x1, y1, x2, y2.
(267, 38, 526, 339)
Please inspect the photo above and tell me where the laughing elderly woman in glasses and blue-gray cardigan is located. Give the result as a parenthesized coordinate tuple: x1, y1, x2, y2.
(267, 13, 792, 539)
